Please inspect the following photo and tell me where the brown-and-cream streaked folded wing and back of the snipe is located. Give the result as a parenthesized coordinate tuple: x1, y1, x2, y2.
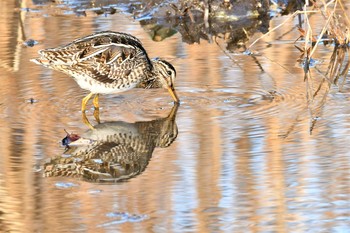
(34, 31, 152, 82)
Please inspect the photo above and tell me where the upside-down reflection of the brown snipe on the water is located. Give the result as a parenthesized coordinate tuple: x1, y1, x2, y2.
(44, 104, 178, 183)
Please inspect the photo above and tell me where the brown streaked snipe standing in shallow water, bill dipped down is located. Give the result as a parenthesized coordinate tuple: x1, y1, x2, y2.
(31, 31, 180, 113)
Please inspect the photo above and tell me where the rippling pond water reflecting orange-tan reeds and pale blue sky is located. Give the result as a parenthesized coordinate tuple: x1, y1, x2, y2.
(0, 1, 350, 232)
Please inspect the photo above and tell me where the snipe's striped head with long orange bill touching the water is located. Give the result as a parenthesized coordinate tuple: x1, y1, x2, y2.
(152, 58, 180, 103)
